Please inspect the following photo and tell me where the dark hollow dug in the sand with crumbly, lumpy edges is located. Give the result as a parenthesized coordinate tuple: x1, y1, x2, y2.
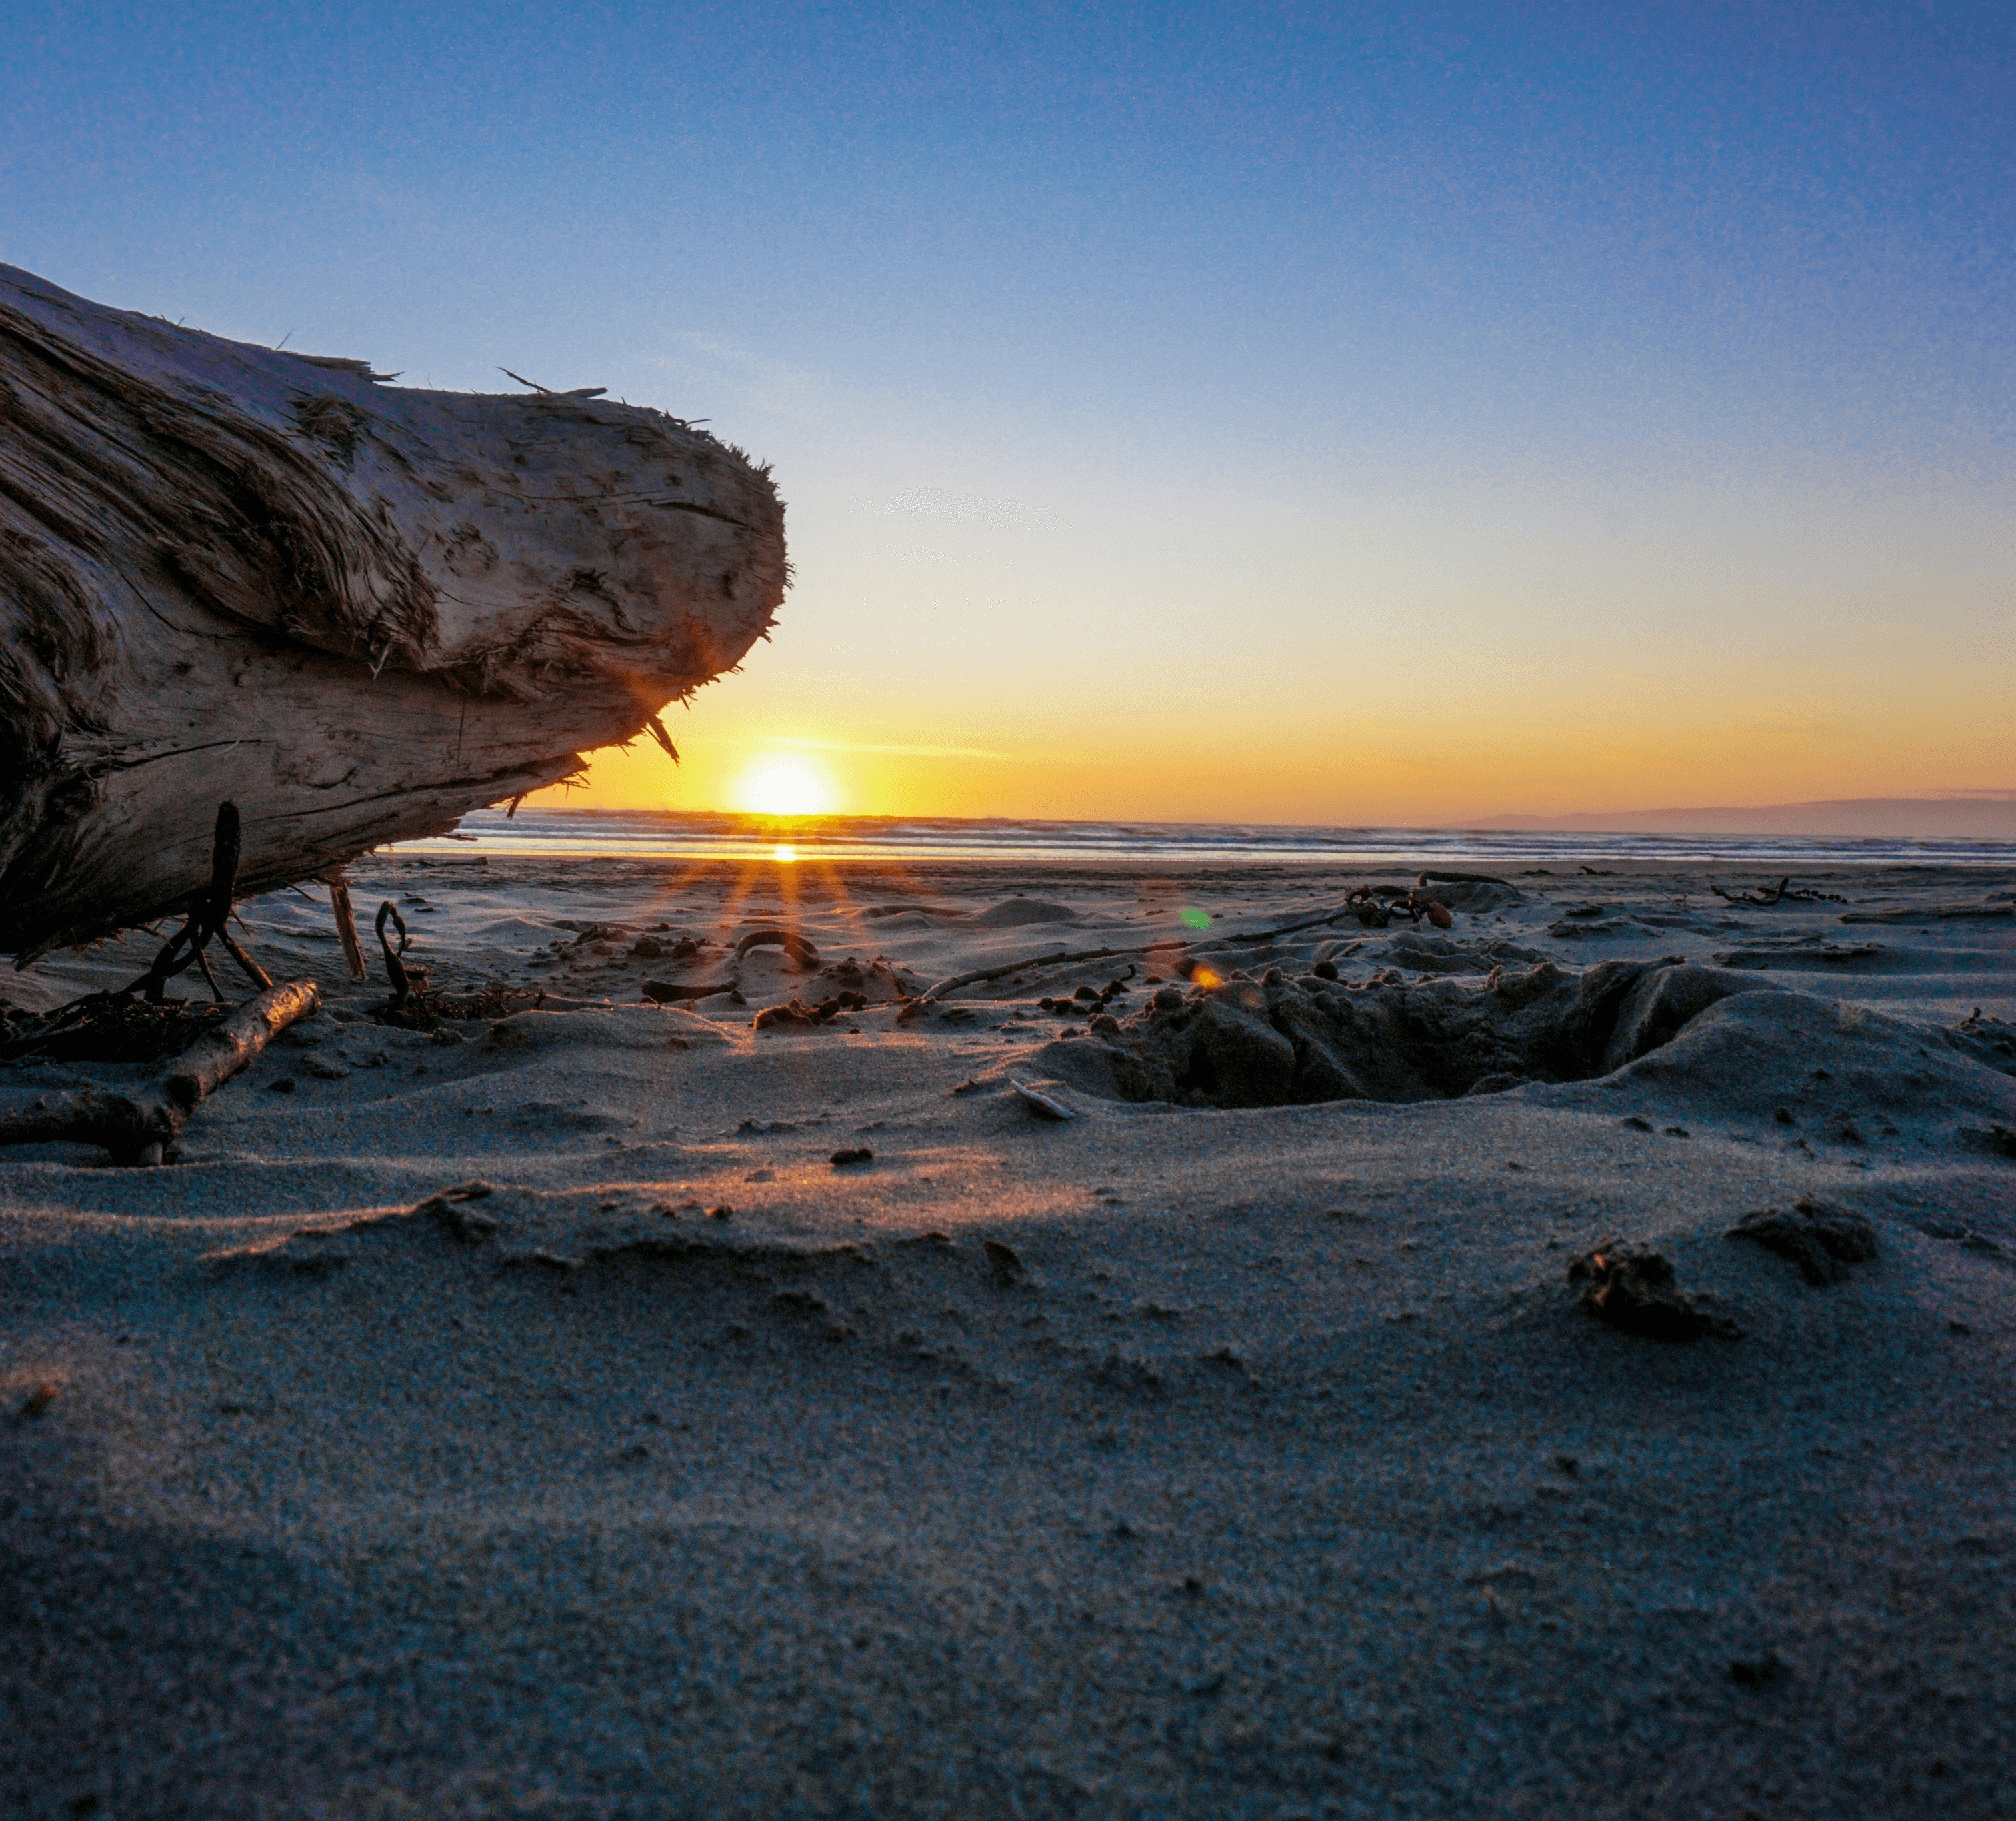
(1053, 962, 1770, 1105)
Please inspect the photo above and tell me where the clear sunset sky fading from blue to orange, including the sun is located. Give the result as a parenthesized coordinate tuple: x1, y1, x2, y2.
(0, 0, 2016, 825)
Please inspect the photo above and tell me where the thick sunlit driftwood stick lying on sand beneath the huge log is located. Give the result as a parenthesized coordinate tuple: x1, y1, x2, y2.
(0, 980, 323, 1164)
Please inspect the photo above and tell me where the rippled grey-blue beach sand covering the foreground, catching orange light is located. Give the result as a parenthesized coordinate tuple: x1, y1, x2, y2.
(0, 859, 2016, 1821)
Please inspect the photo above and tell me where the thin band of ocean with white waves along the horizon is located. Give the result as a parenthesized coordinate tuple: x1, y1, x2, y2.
(409, 809, 2016, 871)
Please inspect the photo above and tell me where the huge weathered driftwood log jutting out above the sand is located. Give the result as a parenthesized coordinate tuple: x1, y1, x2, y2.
(0, 266, 788, 966)
